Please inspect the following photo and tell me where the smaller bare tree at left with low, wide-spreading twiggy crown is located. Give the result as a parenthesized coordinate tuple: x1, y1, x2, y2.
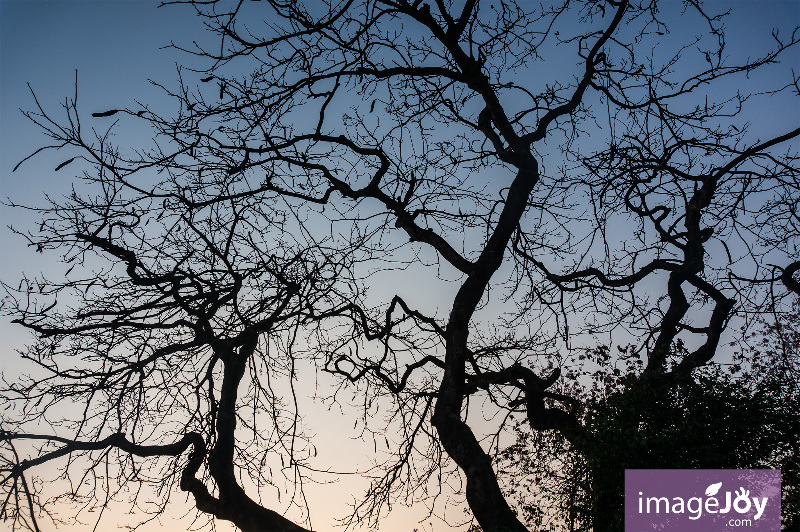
(2, 102, 364, 530)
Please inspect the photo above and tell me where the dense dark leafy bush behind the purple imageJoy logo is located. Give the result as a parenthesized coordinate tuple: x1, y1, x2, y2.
(501, 326, 800, 531)
